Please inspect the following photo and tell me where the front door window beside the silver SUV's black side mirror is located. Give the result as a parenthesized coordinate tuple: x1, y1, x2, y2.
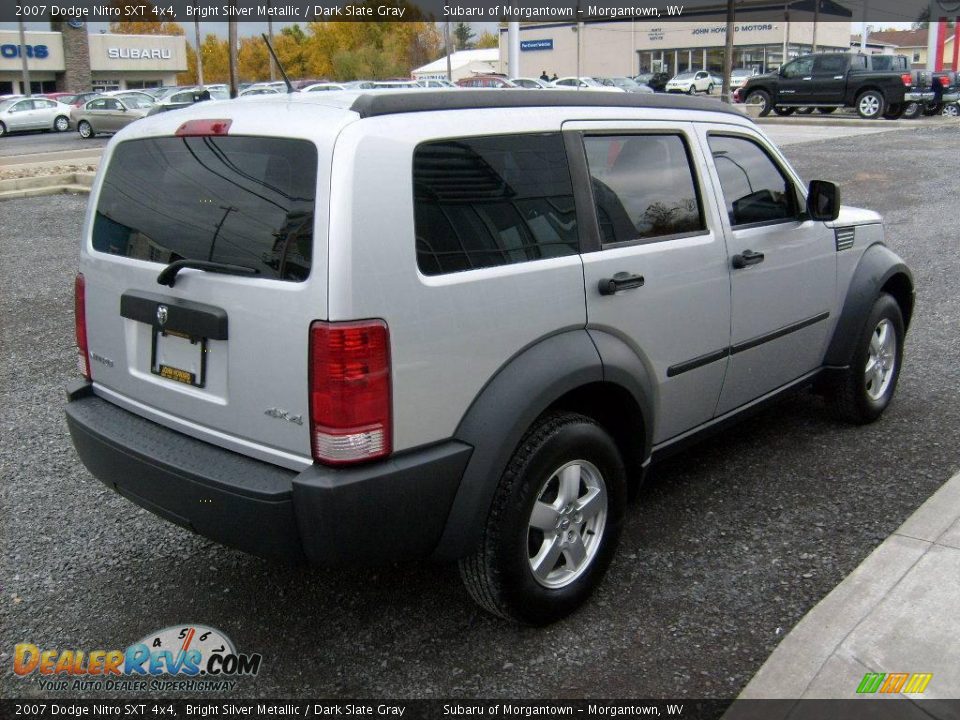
(709, 135, 800, 227)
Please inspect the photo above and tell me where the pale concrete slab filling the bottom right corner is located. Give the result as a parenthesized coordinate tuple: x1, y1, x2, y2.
(738, 466, 960, 700)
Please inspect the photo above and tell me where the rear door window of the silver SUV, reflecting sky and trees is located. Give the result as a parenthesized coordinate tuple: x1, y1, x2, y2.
(584, 135, 706, 244)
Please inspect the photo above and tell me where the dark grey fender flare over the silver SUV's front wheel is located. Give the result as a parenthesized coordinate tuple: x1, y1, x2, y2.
(824, 243, 913, 367)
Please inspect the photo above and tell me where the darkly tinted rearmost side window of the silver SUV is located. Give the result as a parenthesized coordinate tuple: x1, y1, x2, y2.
(413, 133, 579, 275)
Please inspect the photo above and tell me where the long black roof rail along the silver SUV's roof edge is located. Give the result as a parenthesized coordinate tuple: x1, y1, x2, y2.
(350, 89, 746, 118)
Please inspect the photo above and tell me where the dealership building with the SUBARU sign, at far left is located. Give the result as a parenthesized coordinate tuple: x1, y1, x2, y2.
(0, 23, 187, 95)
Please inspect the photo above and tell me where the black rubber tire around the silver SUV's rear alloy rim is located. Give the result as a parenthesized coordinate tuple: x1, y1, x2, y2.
(460, 412, 626, 625)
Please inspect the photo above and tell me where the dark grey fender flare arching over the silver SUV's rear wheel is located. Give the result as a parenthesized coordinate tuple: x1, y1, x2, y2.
(433, 328, 652, 561)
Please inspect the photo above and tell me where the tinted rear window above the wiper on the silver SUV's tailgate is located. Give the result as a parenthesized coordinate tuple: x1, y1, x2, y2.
(93, 137, 317, 281)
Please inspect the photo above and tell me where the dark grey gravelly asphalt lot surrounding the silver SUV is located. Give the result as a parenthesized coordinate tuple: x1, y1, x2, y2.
(0, 126, 960, 698)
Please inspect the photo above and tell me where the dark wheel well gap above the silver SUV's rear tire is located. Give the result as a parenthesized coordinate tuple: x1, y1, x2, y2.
(549, 382, 647, 479)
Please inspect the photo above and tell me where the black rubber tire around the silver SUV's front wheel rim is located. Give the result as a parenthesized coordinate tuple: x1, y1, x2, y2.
(832, 293, 905, 425)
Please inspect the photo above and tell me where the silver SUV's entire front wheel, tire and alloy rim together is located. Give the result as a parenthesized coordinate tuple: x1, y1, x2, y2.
(832, 293, 905, 425)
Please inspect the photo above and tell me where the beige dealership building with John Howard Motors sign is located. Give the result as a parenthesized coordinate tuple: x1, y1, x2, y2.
(500, 11, 851, 77)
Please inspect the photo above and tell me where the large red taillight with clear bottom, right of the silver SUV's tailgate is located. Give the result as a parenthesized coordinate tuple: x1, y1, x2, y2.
(309, 320, 392, 465)
